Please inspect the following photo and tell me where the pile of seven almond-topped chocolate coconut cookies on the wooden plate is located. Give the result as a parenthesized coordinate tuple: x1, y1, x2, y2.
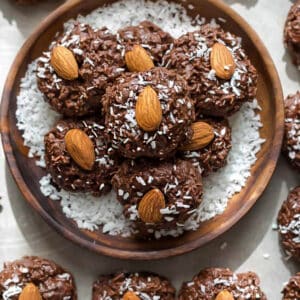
(36, 21, 257, 238)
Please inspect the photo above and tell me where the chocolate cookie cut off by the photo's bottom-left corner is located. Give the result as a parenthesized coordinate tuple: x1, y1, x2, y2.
(0, 256, 77, 300)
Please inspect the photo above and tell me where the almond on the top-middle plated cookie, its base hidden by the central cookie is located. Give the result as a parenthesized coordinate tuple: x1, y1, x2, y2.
(125, 45, 154, 72)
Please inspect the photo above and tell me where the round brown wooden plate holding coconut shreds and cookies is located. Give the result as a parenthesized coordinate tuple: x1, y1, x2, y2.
(1, 0, 284, 260)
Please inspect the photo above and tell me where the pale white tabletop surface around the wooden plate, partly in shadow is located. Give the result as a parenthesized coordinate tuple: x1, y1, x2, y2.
(0, 0, 300, 300)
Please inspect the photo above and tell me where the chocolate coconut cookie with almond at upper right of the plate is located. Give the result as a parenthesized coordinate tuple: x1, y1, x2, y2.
(164, 24, 257, 117)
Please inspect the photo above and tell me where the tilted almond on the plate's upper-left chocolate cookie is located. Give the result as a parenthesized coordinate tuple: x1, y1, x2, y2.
(51, 46, 78, 80)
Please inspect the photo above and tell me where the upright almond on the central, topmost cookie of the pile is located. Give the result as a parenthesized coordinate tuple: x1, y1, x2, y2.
(135, 86, 162, 131)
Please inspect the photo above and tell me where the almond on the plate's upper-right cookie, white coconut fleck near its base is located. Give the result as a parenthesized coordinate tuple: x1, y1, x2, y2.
(210, 43, 236, 79)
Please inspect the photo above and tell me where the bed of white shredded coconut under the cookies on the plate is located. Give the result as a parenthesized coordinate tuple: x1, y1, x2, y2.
(16, 0, 265, 238)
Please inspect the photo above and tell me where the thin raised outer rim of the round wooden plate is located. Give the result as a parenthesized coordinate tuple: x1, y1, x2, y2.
(0, 0, 284, 260)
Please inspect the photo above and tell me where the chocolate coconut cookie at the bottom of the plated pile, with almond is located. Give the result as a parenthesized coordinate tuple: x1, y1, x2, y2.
(112, 159, 202, 238)
